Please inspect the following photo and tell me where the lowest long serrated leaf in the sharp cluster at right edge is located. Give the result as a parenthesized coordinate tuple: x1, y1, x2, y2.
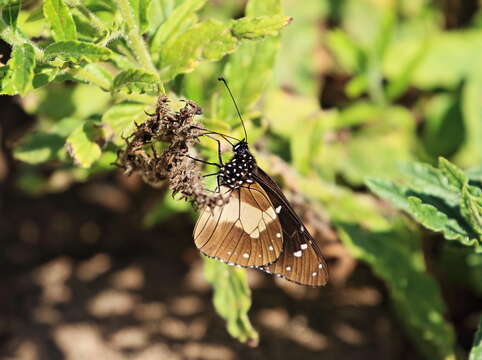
(408, 196, 482, 252)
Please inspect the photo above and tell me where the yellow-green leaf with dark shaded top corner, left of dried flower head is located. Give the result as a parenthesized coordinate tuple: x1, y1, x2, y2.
(66, 121, 103, 168)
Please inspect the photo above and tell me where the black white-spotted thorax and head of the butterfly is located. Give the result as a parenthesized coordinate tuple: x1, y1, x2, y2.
(218, 140, 256, 189)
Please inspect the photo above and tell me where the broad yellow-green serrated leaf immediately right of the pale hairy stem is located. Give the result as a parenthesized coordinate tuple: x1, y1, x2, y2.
(160, 20, 238, 81)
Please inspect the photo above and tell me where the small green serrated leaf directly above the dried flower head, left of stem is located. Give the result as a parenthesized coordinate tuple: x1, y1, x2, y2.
(111, 69, 159, 95)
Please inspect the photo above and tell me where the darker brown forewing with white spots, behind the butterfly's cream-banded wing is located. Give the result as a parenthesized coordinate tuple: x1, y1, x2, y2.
(254, 168, 328, 286)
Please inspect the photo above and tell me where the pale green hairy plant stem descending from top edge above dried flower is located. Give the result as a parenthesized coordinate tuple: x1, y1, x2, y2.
(117, 0, 157, 74)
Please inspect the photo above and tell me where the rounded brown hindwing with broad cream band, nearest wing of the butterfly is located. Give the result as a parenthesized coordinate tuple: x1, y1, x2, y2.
(194, 183, 283, 267)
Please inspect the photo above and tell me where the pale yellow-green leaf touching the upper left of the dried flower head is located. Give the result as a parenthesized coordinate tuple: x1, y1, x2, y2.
(102, 103, 147, 145)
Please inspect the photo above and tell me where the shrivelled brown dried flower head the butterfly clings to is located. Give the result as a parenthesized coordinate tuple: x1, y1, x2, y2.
(117, 95, 227, 208)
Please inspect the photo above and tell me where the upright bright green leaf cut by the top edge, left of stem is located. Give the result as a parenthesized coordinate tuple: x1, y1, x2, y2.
(43, 0, 77, 41)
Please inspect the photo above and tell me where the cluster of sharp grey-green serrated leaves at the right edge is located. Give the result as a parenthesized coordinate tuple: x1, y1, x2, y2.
(367, 158, 482, 253)
